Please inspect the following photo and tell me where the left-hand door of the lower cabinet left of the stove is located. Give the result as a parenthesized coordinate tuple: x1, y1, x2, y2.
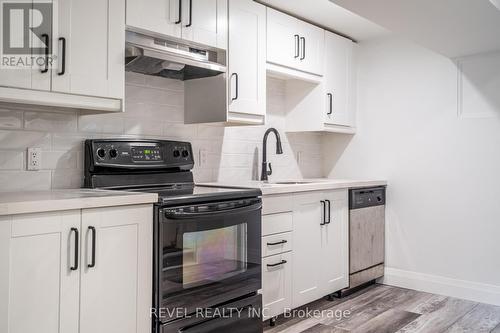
(0, 211, 81, 333)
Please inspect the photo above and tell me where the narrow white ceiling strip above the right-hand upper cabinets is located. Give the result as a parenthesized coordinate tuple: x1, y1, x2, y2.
(256, 0, 388, 41)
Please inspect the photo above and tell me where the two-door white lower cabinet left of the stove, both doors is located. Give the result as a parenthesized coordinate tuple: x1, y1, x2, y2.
(0, 205, 153, 333)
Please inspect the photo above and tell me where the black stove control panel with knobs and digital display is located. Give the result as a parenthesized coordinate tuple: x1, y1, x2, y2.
(85, 139, 194, 170)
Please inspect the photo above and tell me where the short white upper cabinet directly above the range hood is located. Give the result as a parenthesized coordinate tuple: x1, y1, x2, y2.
(127, 0, 228, 49)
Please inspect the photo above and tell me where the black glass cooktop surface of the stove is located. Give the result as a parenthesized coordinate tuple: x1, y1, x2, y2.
(127, 184, 262, 206)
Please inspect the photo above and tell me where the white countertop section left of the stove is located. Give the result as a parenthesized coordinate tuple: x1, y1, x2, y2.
(0, 189, 158, 216)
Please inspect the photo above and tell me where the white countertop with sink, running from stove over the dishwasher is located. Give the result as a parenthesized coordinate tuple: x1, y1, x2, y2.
(197, 178, 387, 195)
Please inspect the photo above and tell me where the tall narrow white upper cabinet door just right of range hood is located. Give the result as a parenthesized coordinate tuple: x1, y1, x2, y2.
(229, 0, 266, 115)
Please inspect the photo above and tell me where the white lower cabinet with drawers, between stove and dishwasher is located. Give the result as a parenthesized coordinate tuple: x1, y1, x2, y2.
(262, 189, 349, 319)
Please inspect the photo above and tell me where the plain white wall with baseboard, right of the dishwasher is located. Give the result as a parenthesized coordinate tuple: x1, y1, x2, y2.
(323, 38, 500, 304)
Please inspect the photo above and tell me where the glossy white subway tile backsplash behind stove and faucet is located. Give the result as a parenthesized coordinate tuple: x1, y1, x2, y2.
(0, 73, 322, 191)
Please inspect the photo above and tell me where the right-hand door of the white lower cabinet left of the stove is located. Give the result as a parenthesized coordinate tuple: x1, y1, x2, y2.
(80, 205, 153, 333)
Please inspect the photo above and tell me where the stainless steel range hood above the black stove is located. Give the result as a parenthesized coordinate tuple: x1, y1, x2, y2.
(125, 31, 226, 81)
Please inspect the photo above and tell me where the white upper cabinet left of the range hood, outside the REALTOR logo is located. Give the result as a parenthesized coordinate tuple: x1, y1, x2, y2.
(0, 0, 125, 111)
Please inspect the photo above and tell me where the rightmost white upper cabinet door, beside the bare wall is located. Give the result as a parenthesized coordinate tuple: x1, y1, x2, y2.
(325, 32, 353, 126)
